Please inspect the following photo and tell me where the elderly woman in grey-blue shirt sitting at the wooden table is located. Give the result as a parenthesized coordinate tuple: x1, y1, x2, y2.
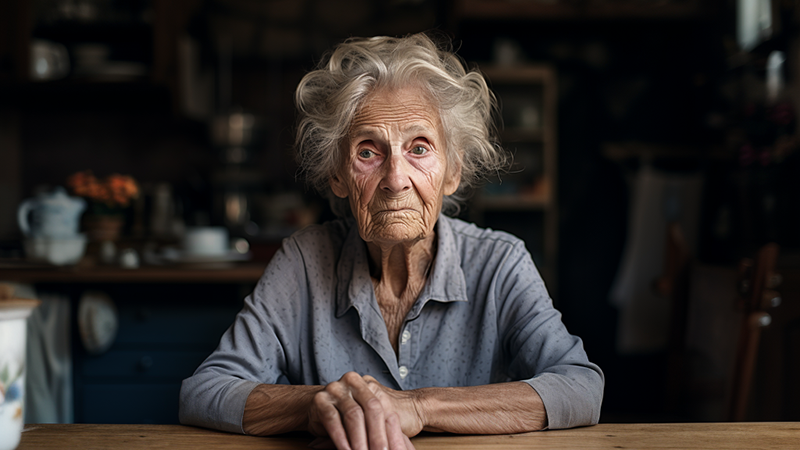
(180, 34, 604, 449)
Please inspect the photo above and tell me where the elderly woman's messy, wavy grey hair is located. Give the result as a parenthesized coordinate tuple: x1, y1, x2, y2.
(295, 33, 509, 217)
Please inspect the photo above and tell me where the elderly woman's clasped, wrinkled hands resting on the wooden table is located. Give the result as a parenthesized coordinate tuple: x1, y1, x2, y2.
(308, 372, 424, 450)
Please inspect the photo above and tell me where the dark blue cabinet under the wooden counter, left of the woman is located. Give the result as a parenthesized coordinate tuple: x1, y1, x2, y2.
(73, 283, 252, 423)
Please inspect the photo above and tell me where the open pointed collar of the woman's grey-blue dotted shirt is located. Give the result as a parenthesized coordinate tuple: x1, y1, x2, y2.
(336, 215, 467, 318)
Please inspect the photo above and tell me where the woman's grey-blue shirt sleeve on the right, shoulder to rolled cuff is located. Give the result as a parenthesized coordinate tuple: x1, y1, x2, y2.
(496, 239, 605, 429)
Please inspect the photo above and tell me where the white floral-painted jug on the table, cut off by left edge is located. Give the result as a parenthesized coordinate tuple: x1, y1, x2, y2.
(0, 300, 39, 450)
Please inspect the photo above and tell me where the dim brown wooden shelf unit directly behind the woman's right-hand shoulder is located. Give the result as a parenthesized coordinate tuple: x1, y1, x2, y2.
(470, 64, 558, 295)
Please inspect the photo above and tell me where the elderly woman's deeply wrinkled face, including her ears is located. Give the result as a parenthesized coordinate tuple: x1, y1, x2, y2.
(331, 87, 460, 245)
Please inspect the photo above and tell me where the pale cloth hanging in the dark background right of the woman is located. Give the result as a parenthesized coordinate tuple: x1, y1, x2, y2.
(609, 165, 703, 354)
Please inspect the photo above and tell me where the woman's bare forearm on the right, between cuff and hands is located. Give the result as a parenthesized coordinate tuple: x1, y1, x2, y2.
(417, 382, 547, 434)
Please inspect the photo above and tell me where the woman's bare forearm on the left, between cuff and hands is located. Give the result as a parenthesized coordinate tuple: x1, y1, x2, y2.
(242, 384, 324, 436)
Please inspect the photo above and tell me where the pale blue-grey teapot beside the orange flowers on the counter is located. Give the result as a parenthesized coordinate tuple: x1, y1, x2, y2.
(17, 186, 86, 238)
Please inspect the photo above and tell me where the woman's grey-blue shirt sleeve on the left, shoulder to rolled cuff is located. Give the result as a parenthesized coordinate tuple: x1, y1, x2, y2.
(179, 238, 304, 433)
